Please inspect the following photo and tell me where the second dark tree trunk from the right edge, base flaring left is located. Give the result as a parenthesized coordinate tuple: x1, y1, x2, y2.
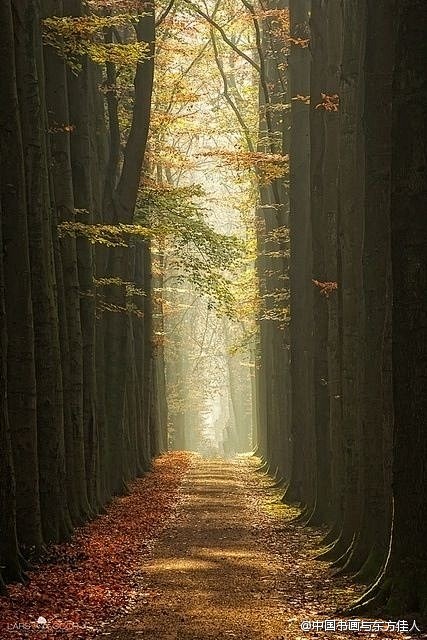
(345, 0, 393, 581)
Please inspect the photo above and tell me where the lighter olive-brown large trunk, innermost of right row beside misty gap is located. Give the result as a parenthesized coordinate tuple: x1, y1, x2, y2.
(286, 0, 316, 517)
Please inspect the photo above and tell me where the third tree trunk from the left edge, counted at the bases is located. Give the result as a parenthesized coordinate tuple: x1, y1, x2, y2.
(13, 0, 71, 542)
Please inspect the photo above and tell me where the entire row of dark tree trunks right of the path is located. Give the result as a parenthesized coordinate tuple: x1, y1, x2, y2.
(259, 0, 427, 615)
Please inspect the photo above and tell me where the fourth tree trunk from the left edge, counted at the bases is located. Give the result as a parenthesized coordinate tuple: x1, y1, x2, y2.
(42, 0, 90, 524)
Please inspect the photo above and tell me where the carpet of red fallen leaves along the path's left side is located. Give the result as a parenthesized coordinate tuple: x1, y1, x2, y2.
(0, 452, 191, 640)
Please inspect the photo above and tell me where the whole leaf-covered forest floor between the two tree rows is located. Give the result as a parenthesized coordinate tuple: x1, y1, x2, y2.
(0, 452, 420, 640)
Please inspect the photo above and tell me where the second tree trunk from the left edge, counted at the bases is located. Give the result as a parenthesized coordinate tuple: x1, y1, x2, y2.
(0, 2, 43, 549)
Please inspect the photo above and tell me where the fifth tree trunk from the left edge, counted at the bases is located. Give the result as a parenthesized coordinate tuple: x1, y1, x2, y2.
(63, 0, 100, 512)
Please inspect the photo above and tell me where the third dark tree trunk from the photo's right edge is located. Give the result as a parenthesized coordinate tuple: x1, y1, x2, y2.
(333, 0, 366, 564)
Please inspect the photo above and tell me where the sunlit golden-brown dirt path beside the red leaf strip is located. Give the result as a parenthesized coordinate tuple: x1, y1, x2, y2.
(98, 459, 402, 640)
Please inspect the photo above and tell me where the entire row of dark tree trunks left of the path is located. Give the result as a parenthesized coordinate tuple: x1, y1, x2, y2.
(0, 0, 166, 592)
